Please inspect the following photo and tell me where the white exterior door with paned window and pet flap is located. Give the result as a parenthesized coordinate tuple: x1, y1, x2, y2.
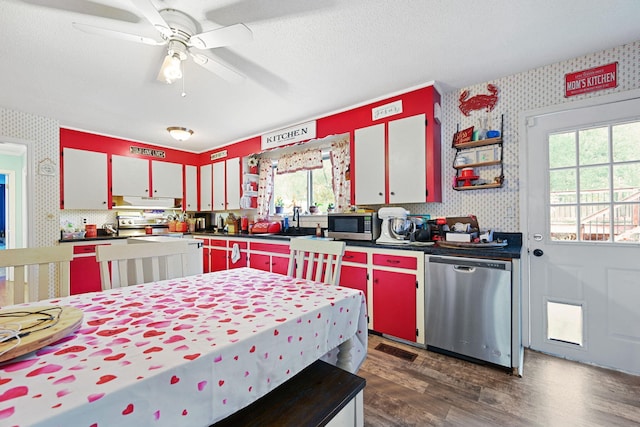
(525, 94, 640, 374)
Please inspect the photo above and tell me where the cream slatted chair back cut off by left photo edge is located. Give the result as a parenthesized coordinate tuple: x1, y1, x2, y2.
(0, 245, 73, 304)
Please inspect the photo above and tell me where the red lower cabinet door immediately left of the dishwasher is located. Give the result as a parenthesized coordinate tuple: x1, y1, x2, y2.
(373, 270, 416, 342)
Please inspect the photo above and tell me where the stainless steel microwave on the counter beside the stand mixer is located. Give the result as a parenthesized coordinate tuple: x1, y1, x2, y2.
(327, 212, 380, 241)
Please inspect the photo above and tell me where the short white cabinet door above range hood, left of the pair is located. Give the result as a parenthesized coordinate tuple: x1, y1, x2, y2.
(111, 154, 151, 197)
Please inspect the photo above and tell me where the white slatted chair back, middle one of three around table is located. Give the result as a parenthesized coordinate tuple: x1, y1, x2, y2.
(96, 238, 189, 290)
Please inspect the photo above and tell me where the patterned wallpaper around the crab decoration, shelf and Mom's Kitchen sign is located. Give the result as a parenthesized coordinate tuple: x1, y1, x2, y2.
(405, 41, 640, 232)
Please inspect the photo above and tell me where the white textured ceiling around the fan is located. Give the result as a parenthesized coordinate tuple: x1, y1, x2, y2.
(0, 0, 640, 152)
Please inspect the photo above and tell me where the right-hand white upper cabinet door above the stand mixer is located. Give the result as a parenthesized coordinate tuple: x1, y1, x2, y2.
(389, 114, 427, 203)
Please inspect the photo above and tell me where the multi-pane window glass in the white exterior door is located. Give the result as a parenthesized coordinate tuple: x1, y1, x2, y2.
(548, 121, 640, 243)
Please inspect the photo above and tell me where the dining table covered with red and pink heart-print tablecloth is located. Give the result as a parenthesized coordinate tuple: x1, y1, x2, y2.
(0, 268, 367, 427)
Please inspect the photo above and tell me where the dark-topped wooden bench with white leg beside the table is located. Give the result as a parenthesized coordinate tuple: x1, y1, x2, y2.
(210, 360, 366, 427)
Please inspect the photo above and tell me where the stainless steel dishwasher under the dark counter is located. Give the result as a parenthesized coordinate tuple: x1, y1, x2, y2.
(425, 255, 511, 367)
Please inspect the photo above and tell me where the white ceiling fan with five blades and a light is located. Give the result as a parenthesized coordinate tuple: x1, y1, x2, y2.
(73, 0, 253, 84)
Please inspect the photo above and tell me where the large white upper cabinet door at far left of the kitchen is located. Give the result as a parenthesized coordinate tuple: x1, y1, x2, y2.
(62, 148, 109, 210)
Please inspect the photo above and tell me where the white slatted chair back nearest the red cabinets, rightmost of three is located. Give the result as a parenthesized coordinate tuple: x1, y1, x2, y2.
(287, 237, 346, 285)
